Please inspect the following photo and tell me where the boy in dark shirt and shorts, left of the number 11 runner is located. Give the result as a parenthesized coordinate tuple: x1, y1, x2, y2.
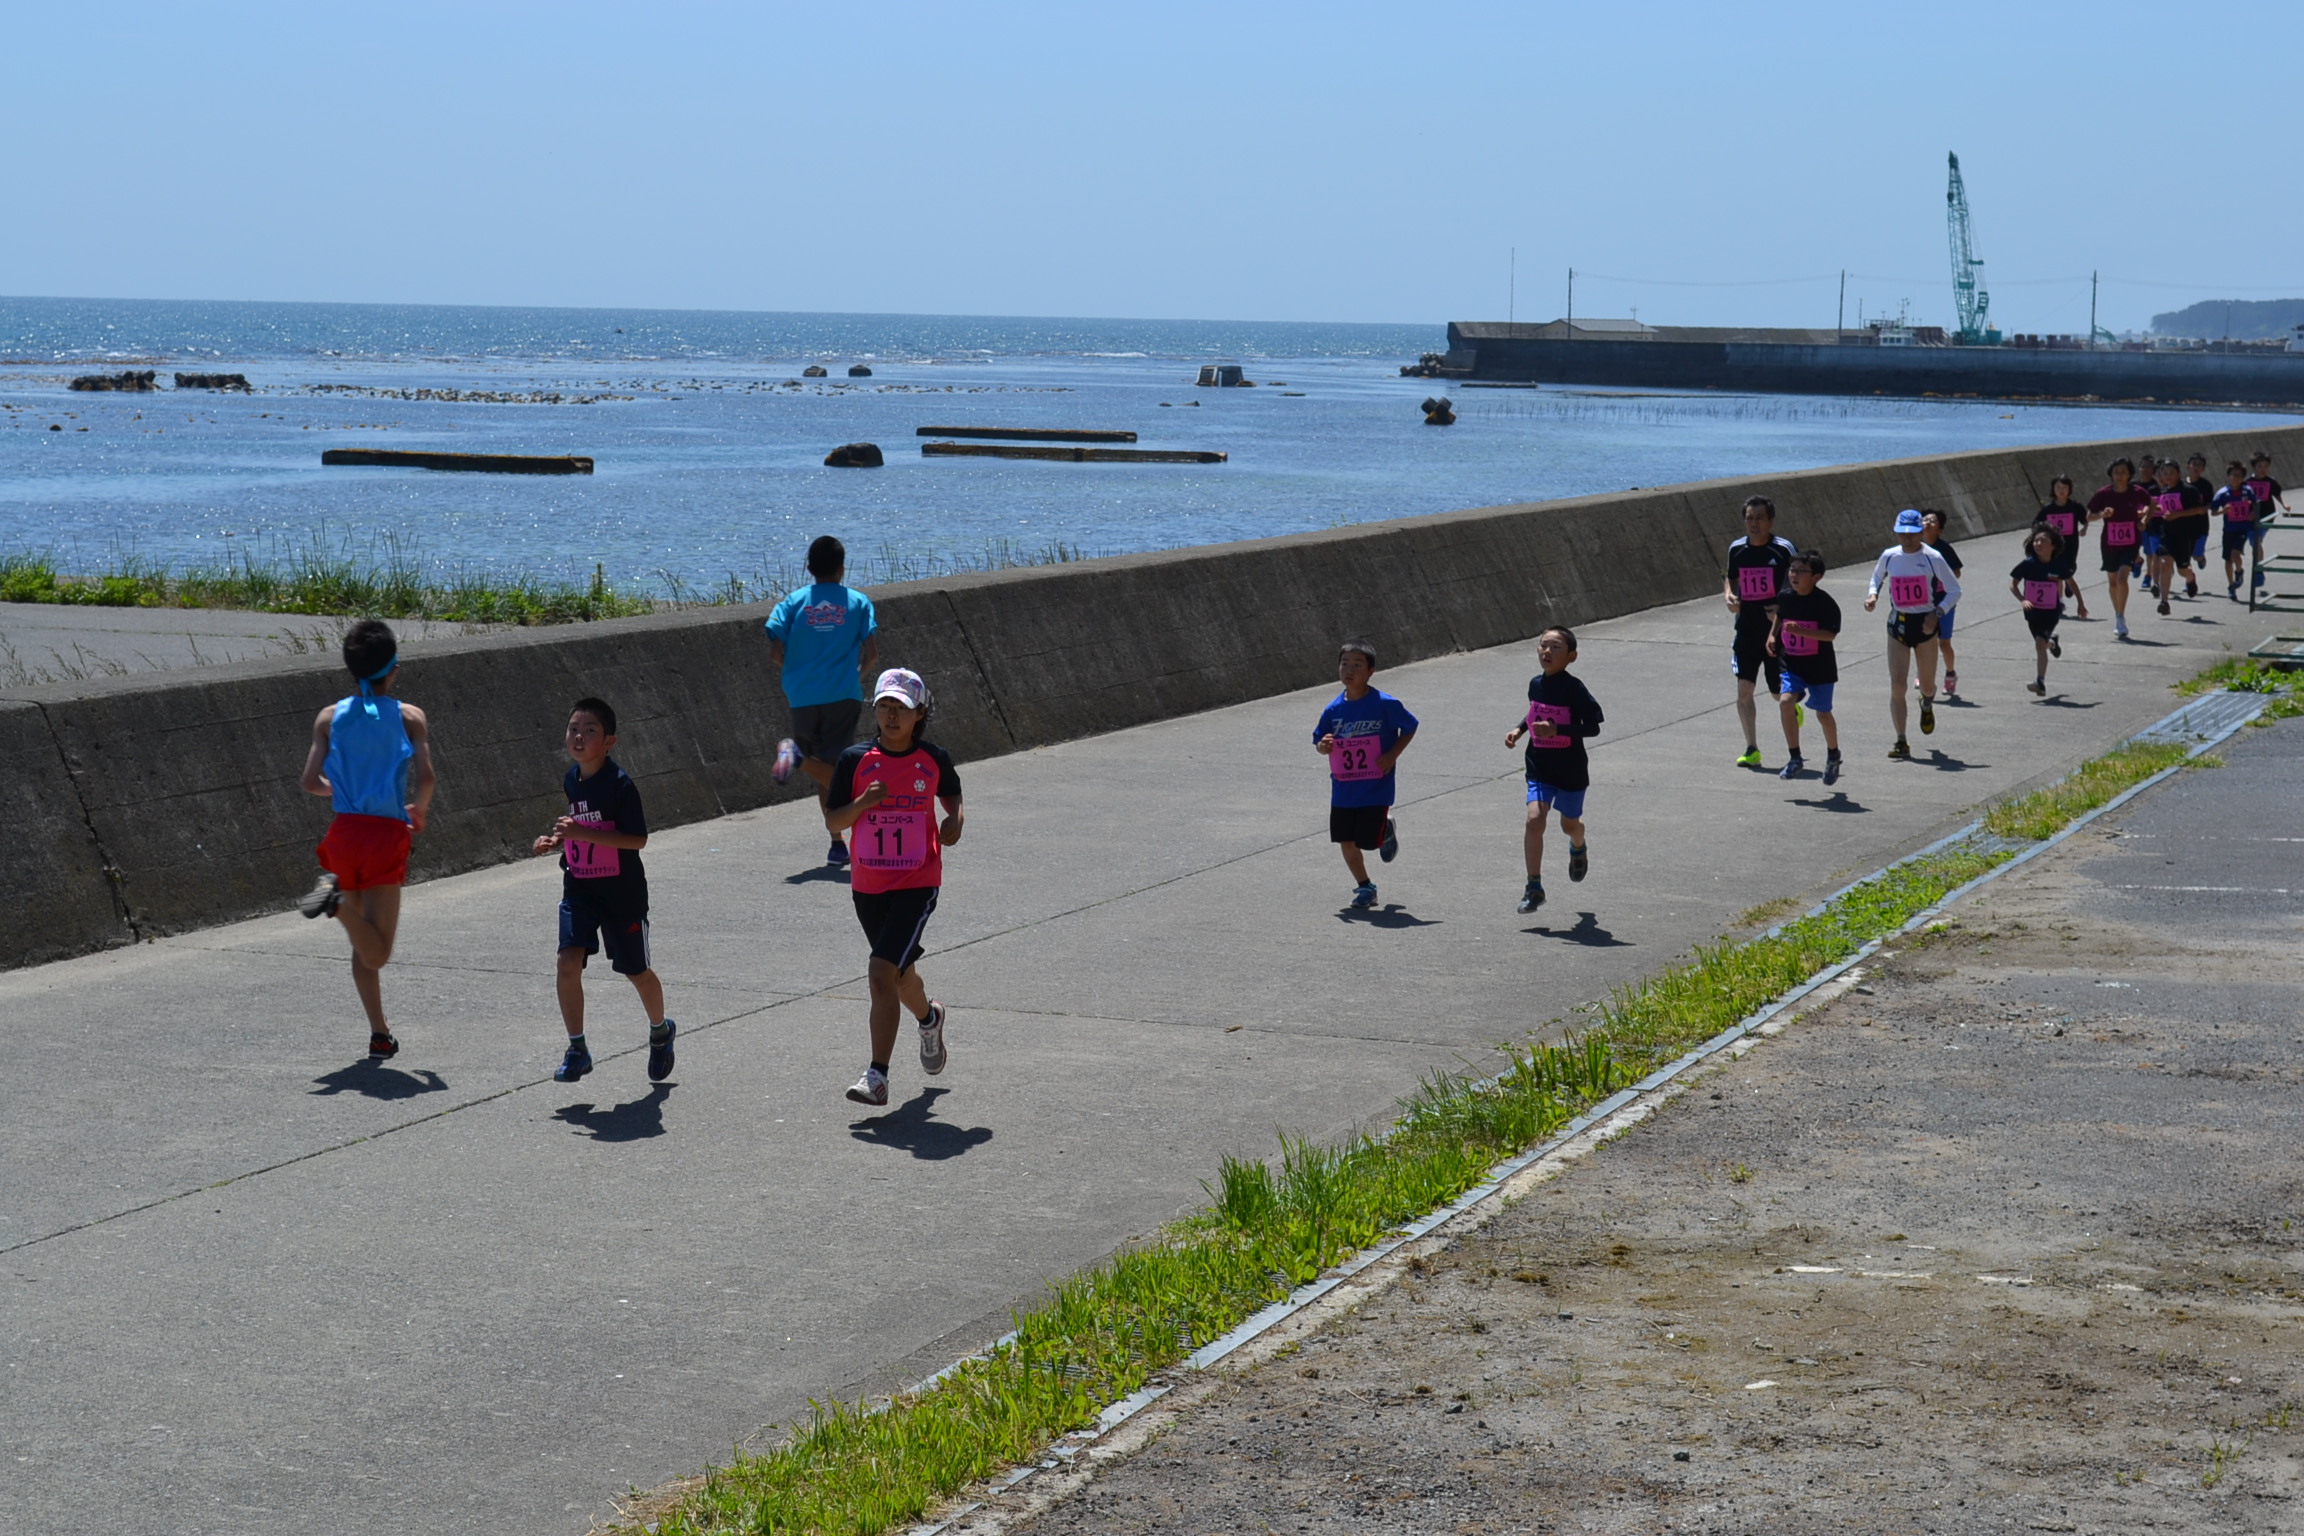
(535, 698, 680, 1082)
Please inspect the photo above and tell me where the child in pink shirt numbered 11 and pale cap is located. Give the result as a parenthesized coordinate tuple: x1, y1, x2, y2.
(825, 668, 968, 1105)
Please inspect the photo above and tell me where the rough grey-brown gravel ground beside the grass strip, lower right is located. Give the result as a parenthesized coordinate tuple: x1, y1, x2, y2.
(986, 721, 2304, 1536)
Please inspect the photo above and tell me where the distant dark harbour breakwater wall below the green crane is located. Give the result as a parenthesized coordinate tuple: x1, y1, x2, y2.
(1442, 322, 2304, 405)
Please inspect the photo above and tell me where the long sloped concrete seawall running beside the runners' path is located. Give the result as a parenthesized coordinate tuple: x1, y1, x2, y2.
(0, 426, 2304, 965)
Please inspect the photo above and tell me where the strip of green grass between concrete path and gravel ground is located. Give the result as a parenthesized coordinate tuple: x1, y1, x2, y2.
(617, 695, 2267, 1536)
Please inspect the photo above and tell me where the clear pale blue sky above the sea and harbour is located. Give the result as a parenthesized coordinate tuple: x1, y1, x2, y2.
(0, 0, 2304, 332)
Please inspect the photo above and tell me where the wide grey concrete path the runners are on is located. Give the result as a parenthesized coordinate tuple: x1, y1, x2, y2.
(0, 537, 2263, 1536)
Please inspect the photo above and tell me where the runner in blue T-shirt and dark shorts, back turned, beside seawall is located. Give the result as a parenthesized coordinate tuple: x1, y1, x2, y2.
(767, 534, 880, 868)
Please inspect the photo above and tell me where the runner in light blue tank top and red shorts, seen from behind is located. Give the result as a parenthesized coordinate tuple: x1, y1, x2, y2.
(297, 619, 435, 1057)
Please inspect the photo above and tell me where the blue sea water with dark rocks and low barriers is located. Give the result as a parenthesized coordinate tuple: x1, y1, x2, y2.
(0, 299, 2274, 594)
